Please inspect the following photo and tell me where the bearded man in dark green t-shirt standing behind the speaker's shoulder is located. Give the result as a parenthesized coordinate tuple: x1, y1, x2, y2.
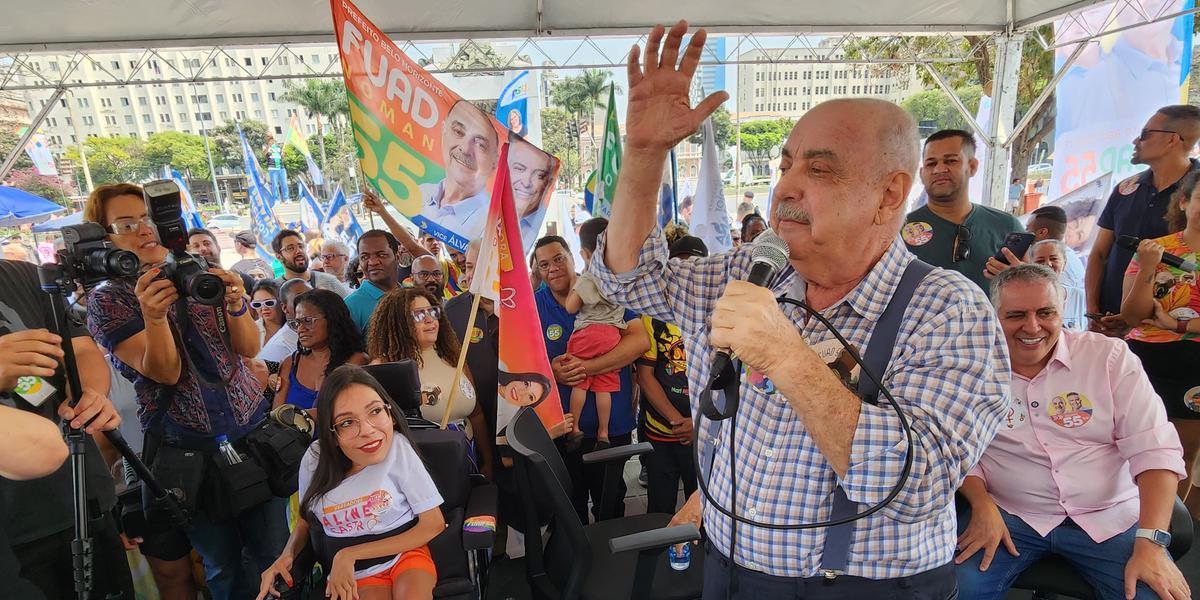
(900, 130, 1025, 292)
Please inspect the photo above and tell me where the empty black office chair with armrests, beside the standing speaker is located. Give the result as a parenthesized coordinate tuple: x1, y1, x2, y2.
(508, 407, 704, 600)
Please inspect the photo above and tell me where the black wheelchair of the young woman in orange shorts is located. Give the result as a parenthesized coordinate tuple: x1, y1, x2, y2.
(285, 428, 497, 600)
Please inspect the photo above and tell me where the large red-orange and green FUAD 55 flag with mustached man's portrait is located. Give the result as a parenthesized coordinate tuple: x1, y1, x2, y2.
(330, 0, 557, 251)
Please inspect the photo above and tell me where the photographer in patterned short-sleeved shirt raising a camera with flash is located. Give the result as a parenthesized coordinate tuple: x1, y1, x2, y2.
(84, 184, 288, 600)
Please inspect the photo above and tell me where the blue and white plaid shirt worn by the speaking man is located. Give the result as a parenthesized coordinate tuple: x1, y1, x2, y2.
(592, 230, 1009, 580)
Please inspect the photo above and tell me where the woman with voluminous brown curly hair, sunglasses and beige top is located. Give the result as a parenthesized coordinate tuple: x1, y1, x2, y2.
(367, 288, 492, 479)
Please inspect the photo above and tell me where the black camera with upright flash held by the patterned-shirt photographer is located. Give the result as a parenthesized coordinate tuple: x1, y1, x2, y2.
(143, 179, 224, 306)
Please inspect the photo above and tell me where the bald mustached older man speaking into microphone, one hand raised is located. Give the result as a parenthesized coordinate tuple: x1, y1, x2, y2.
(592, 22, 1009, 599)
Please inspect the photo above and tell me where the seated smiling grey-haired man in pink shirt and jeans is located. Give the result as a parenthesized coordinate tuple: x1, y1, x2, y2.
(954, 264, 1192, 600)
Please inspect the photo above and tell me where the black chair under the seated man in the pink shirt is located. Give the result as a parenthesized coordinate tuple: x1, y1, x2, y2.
(958, 498, 1194, 600)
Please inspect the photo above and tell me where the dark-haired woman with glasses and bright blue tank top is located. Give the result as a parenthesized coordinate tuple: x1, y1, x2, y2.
(274, 289, 367, 410)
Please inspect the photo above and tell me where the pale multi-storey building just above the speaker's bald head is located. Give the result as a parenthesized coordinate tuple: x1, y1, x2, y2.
(738, 40, 918, 119)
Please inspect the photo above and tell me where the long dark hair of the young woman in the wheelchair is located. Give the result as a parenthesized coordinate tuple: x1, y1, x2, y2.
(300, 362, 420, 518)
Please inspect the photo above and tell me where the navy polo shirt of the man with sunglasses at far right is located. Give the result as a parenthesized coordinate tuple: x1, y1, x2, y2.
(1098, 158, 1200, 313)
